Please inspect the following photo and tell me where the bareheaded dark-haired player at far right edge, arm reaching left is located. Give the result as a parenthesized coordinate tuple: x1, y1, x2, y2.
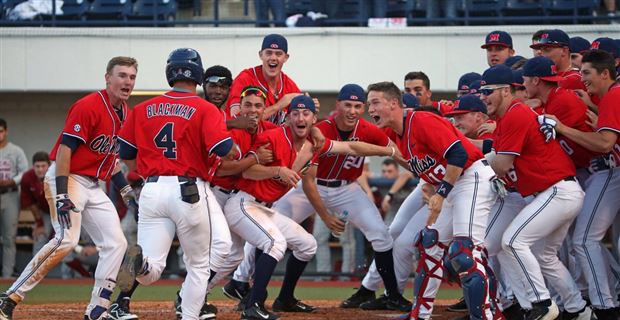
(549, 50, 620, 320)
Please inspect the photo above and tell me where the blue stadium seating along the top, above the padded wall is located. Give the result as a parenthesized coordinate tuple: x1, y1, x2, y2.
(0, 0, 615, 27)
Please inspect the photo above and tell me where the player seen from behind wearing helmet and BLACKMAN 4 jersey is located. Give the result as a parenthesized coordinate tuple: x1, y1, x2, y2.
(117, 48, 234, 319)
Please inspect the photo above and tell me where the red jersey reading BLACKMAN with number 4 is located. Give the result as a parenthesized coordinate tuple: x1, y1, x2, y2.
(120, 91, 230, 180)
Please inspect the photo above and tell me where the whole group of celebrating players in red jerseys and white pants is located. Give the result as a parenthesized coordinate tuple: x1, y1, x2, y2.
(0, 29, 620, 320)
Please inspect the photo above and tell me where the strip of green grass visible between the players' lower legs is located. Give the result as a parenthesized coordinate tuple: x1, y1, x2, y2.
(0, 283, 461, 304)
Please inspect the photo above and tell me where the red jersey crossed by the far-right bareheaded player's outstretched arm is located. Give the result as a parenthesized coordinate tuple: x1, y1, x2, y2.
(543, 88, 596, 168)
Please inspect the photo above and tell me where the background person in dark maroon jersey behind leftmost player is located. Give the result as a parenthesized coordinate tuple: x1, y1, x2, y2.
(20, 151, 54, 255)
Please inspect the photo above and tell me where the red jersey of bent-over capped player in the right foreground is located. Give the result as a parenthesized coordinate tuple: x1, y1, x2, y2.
(493, 100, 575, 197)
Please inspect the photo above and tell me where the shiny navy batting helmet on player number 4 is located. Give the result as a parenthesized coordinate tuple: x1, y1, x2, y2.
(166, 48, 204, 87)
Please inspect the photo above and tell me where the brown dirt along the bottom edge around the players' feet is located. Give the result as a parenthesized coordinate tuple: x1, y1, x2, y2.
(13, 300, 462, 320)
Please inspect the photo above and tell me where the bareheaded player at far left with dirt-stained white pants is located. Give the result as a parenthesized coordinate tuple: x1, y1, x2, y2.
(0, 57, 138, 319)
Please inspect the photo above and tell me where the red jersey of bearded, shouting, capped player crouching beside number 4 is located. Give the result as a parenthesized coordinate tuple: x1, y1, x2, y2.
(237, 126, 322, 202)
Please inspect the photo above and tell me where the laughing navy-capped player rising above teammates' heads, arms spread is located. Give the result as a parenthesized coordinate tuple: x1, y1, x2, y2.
(227, 34, 301, 125)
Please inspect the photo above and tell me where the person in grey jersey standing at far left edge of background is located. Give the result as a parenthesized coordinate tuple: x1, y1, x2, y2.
(0, 119, 28, 278)
